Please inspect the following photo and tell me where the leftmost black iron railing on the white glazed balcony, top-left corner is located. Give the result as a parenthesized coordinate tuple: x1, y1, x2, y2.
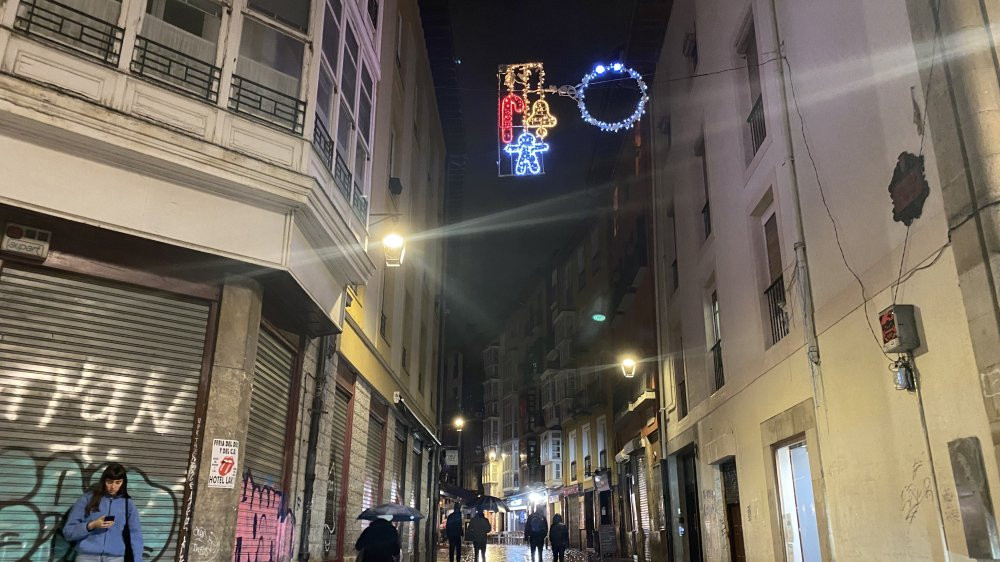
(14, 0, 125, 65)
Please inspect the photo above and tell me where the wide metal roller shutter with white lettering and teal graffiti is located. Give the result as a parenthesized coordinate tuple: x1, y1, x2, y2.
(0, 267, 209, 560)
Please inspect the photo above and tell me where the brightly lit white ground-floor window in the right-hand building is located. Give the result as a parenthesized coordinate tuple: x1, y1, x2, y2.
(774, 440, 823, 562)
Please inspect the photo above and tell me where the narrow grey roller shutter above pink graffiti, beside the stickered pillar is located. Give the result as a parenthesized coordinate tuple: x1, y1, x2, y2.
(244, 328, 295, 486)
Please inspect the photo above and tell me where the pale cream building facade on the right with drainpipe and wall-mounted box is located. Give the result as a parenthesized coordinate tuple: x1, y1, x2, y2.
(650, 0, 1000, 560)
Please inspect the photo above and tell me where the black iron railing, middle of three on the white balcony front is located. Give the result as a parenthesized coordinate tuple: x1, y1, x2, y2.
(130, 36, 222, 103)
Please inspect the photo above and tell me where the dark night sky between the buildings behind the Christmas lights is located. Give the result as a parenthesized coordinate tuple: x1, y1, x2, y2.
(446, 0, 634, 350)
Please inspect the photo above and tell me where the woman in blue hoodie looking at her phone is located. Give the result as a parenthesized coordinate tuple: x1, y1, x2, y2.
(63, 463, 142, 562)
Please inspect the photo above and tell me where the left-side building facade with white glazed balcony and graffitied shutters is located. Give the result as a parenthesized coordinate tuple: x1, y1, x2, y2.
(0, 0, 444, 560)
